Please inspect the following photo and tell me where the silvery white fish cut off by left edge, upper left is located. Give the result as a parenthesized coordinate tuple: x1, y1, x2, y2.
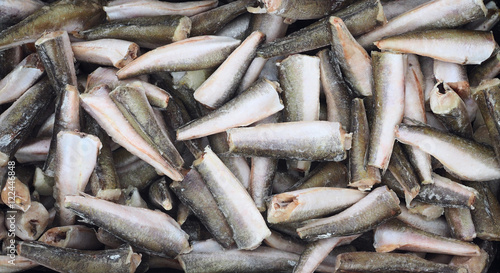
(0, 53, 45, 104)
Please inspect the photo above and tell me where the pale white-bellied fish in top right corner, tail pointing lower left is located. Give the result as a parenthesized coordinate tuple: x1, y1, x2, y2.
(358, 0, 486, 48)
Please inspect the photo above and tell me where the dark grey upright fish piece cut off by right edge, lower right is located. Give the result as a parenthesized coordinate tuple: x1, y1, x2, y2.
(464, 182, 500, 241)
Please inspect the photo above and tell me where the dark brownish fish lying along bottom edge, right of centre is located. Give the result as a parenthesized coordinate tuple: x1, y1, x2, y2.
(335, 252, 467, 273)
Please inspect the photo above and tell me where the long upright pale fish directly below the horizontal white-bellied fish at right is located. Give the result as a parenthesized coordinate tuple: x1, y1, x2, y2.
(367, 52, 406, 171)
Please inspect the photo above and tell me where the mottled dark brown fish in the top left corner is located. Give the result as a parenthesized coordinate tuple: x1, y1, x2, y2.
(0, 0, 106, 50)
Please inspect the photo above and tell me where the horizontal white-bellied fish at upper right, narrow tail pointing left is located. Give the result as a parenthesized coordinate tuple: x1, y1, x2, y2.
(375, 29, 496, 64)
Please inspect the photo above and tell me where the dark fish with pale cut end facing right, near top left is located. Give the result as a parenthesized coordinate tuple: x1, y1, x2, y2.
(77, 15, 191, 48)
